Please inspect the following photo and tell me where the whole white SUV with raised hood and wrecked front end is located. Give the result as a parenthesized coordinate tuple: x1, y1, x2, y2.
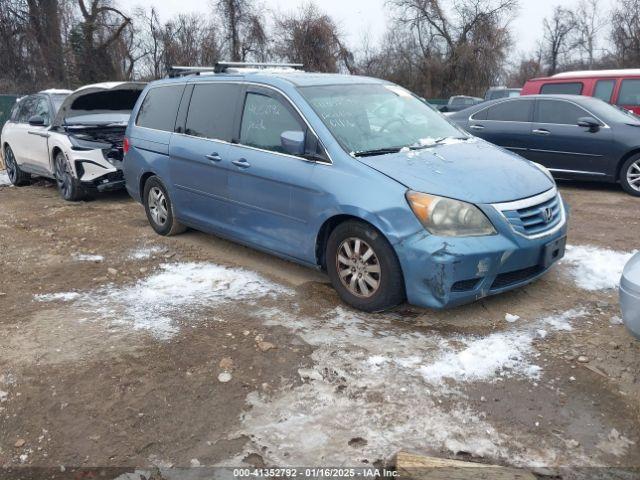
(0, 82, 145, 201)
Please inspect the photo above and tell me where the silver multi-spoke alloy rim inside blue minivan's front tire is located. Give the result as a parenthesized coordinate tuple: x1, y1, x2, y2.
(336, 237, 381, 298)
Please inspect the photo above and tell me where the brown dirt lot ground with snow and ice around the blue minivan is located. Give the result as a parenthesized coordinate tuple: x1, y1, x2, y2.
(0, 177, 640, 478)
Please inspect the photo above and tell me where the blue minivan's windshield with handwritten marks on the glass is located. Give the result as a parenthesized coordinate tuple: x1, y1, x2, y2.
(299, 84, 468, 155)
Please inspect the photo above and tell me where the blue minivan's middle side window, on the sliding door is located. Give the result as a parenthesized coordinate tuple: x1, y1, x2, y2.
(185, 83, 240, 142)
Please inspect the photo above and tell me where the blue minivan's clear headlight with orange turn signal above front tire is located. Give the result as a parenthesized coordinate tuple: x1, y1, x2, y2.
(407, 191, 496, 237)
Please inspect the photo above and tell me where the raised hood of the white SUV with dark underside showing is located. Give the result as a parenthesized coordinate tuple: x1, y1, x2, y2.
(52, 82, 146, 126)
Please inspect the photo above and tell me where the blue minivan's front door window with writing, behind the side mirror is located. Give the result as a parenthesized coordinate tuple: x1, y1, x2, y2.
(240, 93, 306, 153)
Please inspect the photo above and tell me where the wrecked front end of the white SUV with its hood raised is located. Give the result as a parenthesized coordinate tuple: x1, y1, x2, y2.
(48, 82, 146, 200)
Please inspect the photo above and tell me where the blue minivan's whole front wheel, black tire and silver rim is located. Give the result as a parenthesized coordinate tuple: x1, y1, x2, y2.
(326, 220, 405, 312)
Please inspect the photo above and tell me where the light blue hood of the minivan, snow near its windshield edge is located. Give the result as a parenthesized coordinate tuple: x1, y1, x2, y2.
(358, 138, 554, 203)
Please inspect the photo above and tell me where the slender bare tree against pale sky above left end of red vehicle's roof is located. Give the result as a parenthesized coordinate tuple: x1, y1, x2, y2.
(543, 6, 578, 75)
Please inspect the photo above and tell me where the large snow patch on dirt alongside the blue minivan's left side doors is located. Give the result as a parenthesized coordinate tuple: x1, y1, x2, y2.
(36, 263, 288, 339)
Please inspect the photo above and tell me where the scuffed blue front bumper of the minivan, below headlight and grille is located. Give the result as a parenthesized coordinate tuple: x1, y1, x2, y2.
(394, 196, 568, 308)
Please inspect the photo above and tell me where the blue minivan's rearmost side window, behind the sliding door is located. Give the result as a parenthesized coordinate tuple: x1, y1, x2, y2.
(136, 85, 184, 132)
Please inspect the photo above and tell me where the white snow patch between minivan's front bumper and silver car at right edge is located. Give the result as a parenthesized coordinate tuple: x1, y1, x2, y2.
(561, 245, 637, 291)
